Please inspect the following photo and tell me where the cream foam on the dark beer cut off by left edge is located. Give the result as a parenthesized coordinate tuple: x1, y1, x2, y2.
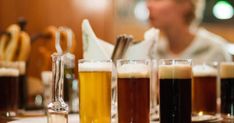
(0, 68, 19, 76)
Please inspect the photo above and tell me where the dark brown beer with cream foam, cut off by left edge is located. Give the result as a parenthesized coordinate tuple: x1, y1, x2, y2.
(0, 68, 19, 115)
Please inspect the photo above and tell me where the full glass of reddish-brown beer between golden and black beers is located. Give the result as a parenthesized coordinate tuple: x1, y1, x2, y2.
(117, 60, 151, 123)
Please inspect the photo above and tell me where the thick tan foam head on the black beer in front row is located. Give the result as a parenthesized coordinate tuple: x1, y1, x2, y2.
(158, 64, 192, 79)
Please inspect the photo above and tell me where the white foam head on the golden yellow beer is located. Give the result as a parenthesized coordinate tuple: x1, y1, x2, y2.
(79, 61, 112, 71)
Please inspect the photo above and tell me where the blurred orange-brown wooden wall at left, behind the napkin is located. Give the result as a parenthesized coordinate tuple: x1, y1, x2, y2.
(0, 0, 114, 77)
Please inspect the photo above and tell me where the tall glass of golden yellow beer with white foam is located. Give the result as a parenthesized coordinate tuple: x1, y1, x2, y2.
(78, 60, 113, 123)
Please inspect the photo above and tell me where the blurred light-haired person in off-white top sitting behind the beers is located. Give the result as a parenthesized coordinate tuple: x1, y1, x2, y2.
(147, 0, 231, 64)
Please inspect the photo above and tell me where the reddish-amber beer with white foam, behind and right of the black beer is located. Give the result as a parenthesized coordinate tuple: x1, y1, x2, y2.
(192, 64, 218, 114)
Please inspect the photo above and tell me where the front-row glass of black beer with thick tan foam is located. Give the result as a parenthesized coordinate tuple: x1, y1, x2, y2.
(158, 59, 192, 123)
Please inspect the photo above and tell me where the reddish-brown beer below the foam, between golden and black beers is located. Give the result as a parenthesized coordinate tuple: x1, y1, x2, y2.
(118, 78, 150, 123)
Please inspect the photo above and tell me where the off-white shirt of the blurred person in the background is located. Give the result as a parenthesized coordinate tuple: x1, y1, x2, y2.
(151, 28, 231, 64)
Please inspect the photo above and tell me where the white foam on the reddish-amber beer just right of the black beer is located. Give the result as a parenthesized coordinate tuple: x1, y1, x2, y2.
(193, 64, 218, 76)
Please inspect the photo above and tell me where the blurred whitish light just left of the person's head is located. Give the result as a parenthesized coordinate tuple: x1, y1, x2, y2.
(134, 1, 149, 21)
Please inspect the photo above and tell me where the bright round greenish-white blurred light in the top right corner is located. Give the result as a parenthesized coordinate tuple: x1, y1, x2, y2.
(213, 1, 234, 20)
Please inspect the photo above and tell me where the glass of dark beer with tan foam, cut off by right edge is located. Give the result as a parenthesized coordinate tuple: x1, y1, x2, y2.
(220, 62, 234, 120)
